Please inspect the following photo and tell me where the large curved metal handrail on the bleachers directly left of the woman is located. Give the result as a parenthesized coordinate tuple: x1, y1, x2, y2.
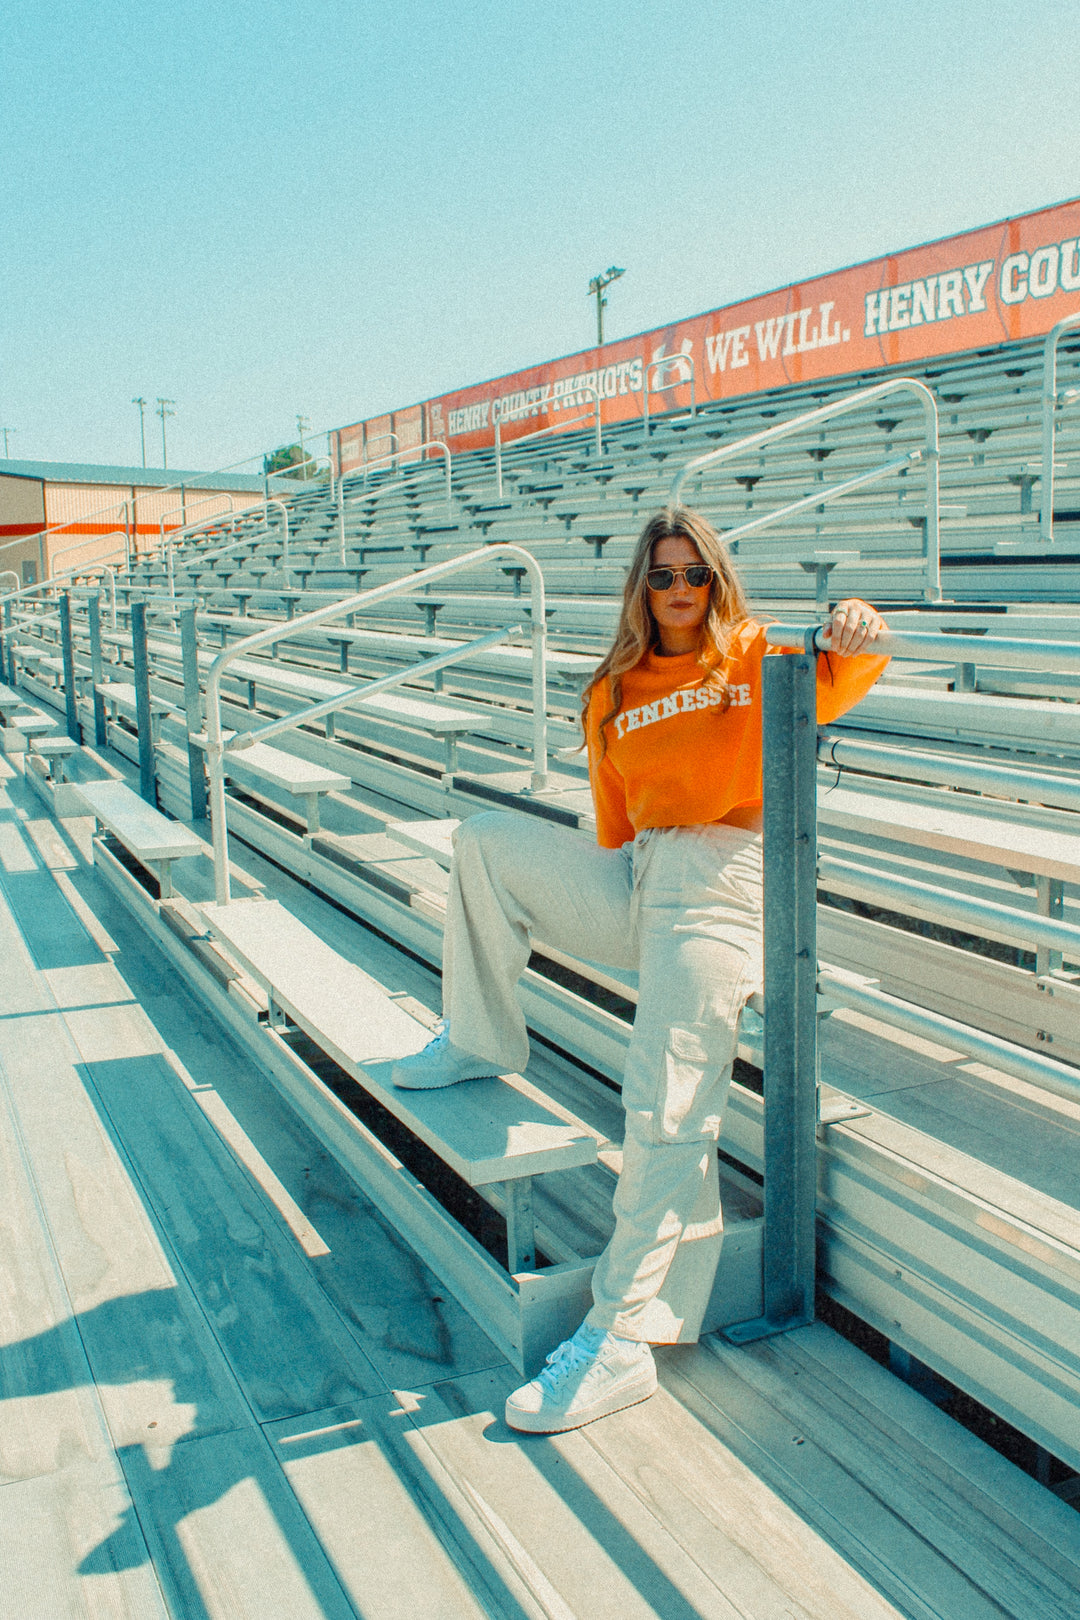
(206, 543, 547, 906)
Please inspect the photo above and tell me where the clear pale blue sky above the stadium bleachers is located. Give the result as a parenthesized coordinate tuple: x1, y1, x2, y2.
(0, 0, 1080, 468)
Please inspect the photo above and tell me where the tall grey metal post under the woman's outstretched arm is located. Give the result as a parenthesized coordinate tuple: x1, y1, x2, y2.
(727, 653, 818, 1343)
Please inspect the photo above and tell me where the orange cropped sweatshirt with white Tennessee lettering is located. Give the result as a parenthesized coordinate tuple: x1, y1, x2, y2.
(586, 619, 889, 849)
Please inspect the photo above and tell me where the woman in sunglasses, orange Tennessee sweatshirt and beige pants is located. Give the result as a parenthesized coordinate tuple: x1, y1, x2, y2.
(393, 507, 886, 1432)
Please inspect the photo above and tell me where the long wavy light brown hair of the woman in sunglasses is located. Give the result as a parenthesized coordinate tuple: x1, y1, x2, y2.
(581, 507, 750, 758)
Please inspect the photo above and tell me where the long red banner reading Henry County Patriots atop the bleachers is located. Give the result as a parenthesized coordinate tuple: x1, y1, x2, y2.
(337, 199, 1080, 473)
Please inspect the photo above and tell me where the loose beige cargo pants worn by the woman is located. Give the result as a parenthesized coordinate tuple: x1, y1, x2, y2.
(444, 812, 761, 1345)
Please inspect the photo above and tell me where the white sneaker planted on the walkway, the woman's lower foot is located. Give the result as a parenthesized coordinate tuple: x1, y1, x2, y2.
(507, 1322, 656, 1434)
